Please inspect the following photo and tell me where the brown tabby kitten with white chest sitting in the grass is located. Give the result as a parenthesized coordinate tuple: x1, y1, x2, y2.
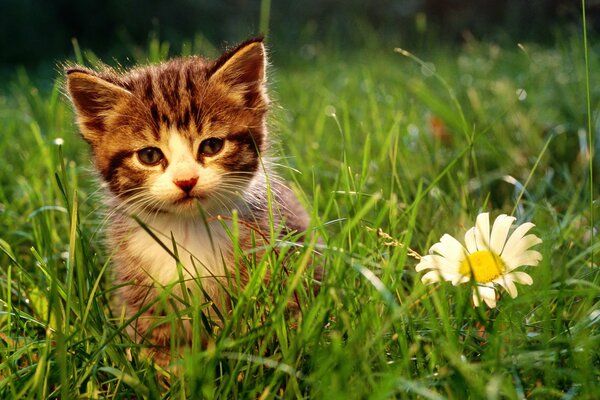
(67, 38, 309, 365)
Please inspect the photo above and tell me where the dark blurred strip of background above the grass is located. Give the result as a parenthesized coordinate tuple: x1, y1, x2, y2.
(0, 0, 600, 72)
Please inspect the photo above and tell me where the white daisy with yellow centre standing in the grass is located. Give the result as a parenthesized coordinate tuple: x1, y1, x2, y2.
(416, 213, 542, 308)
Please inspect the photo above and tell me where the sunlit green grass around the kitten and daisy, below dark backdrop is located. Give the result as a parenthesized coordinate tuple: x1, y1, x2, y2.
(0, 32, 600, 399)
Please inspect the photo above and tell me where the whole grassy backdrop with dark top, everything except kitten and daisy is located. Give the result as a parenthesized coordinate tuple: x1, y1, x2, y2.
(0, 0, 600, 400)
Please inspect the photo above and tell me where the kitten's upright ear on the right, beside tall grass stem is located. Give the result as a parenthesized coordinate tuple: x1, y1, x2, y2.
(210, 38, 267, 87)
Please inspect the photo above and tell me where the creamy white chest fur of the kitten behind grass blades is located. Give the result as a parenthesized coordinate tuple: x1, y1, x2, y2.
(126, 215, 231, 286)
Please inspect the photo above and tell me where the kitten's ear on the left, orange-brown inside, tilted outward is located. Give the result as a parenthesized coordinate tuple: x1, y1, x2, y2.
(67, 68, 132, 141)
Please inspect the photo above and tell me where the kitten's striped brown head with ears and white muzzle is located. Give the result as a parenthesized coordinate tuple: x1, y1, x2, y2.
(67, 39, 268, 213)
